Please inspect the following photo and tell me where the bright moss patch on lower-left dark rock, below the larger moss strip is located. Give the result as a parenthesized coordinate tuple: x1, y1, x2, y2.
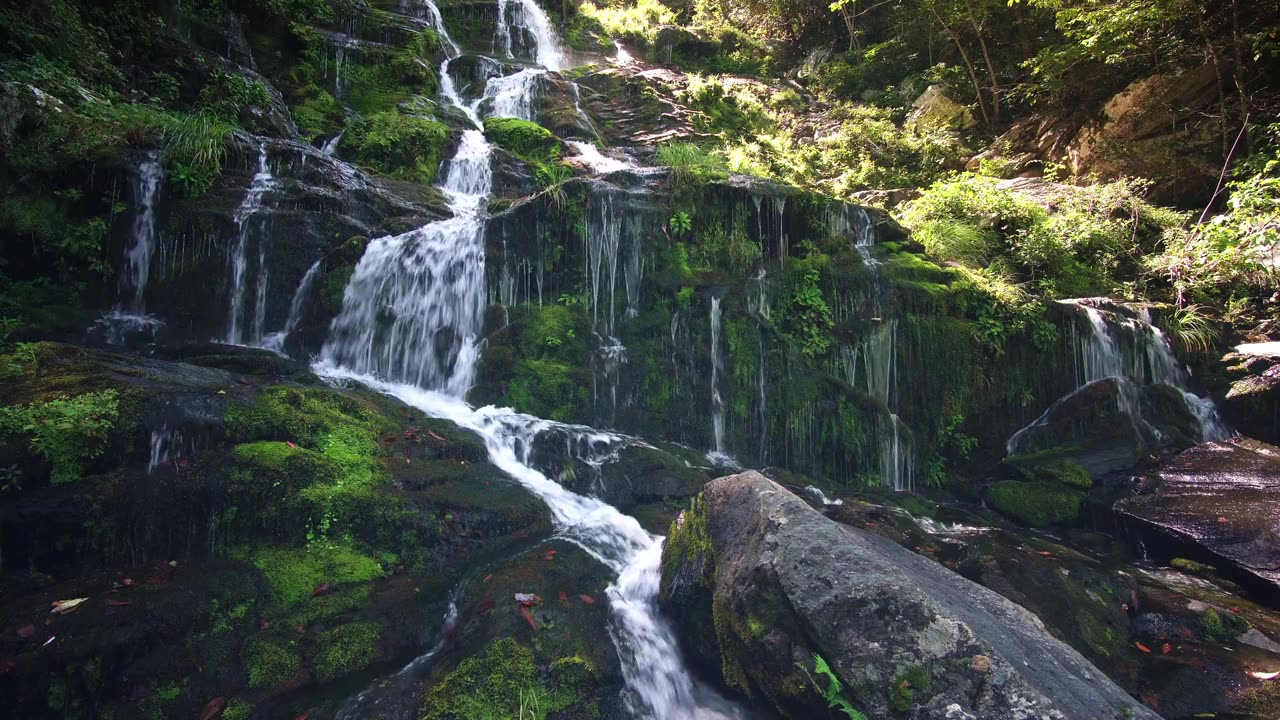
(253, 543, 385, 606)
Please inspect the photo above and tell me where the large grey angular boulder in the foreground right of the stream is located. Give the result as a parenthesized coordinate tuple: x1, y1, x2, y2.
(660, 471, 1158, 720)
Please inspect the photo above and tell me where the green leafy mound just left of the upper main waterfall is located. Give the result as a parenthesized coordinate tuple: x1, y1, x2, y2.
(340, 113, 449, 184)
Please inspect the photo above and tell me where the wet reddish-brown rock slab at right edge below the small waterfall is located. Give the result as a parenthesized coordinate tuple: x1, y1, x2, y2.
(1116, 439, 1280, 597)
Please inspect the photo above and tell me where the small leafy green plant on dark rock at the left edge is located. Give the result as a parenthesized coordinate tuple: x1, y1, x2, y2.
(0, 389, 119, 484)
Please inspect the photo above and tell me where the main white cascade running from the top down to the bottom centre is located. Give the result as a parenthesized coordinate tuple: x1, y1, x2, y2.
(315, 0, 737, 720)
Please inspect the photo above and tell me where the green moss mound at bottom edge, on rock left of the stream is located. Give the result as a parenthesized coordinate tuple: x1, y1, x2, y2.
(422, 638, 538, 720)
